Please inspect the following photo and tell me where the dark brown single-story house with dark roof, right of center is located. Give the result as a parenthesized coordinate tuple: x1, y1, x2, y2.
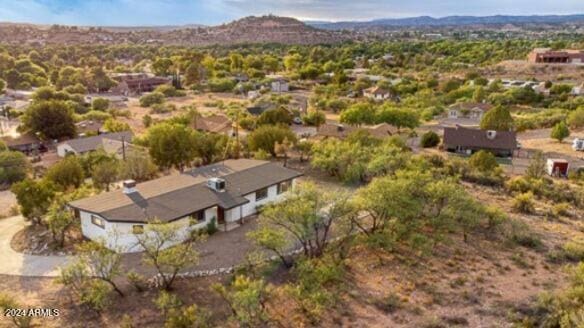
(443, 126, 518, 157)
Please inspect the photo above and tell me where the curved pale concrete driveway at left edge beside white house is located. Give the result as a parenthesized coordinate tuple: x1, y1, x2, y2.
(0, 216, 71, 277)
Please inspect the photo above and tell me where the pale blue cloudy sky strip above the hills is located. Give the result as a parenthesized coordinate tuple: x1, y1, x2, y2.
(0, 0, 584, 26)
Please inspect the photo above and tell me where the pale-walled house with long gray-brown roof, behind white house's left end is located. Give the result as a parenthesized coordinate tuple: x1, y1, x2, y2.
(57, 131, 133, 157)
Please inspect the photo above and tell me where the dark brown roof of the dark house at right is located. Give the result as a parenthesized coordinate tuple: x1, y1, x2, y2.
(444, 126, 517, 150)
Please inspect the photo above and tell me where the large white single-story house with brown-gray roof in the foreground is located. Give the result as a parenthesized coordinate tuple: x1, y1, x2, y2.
(69, 159, 301, 252)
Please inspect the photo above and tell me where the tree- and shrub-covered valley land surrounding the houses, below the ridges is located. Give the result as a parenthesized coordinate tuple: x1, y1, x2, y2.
(0, 31, 584, 328)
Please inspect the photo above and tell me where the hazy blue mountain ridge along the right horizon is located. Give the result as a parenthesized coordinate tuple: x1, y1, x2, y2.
(305, 14, 584, 30)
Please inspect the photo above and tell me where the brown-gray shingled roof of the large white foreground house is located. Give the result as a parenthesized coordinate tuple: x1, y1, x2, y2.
(69, 159, 301, 222)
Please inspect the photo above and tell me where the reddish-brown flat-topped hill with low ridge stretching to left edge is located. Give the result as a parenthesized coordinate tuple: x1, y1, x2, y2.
(0, 15, 349, 46)
